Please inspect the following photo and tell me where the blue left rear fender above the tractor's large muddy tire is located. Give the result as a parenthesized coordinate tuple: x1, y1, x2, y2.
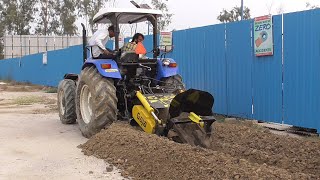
(82, 58, 121, 79)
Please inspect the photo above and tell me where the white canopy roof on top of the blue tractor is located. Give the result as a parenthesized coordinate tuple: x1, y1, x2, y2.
(93, 8, 162, 24)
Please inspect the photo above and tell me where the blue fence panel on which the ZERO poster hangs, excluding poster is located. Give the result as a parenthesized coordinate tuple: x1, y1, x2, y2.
(252, 15, 282, 123)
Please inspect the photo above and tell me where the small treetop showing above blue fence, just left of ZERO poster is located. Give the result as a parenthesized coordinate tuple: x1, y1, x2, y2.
(217, 7, 251, 23)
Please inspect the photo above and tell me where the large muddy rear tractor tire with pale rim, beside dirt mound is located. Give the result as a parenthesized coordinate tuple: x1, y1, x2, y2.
(76, 66, 118, 138)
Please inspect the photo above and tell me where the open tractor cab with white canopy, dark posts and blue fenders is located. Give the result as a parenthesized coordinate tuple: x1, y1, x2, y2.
(83, 8, 171, 80)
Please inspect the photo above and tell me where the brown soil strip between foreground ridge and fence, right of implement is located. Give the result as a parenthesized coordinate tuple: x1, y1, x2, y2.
(211, 121, 320, 178)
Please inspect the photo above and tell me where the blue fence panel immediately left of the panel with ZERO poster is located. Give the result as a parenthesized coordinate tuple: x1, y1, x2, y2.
(226, 21, 253, 118)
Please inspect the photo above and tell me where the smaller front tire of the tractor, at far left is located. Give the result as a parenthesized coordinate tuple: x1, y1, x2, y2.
(58, 79, 77, 124)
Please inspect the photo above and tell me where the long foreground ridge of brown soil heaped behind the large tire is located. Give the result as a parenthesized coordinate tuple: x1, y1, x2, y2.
(80, 123, 319, 180)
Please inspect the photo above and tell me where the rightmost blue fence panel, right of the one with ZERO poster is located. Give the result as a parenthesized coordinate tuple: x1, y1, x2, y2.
(284, 10, 320, 132)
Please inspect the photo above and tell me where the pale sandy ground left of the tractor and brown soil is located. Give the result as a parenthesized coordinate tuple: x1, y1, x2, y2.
(0, 82, 124, 180)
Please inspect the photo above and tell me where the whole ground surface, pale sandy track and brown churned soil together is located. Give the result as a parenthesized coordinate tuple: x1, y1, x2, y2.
(0, 84, 320, 180)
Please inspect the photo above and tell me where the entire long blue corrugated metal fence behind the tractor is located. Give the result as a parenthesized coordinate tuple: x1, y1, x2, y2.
(0, 9, 320, 132)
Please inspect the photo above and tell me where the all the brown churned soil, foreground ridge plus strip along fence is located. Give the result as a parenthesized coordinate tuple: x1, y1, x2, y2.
(81, 122, 320, 180)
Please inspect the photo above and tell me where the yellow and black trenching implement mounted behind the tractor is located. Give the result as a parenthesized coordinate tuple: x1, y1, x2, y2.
(132, 89, 215, 147)
